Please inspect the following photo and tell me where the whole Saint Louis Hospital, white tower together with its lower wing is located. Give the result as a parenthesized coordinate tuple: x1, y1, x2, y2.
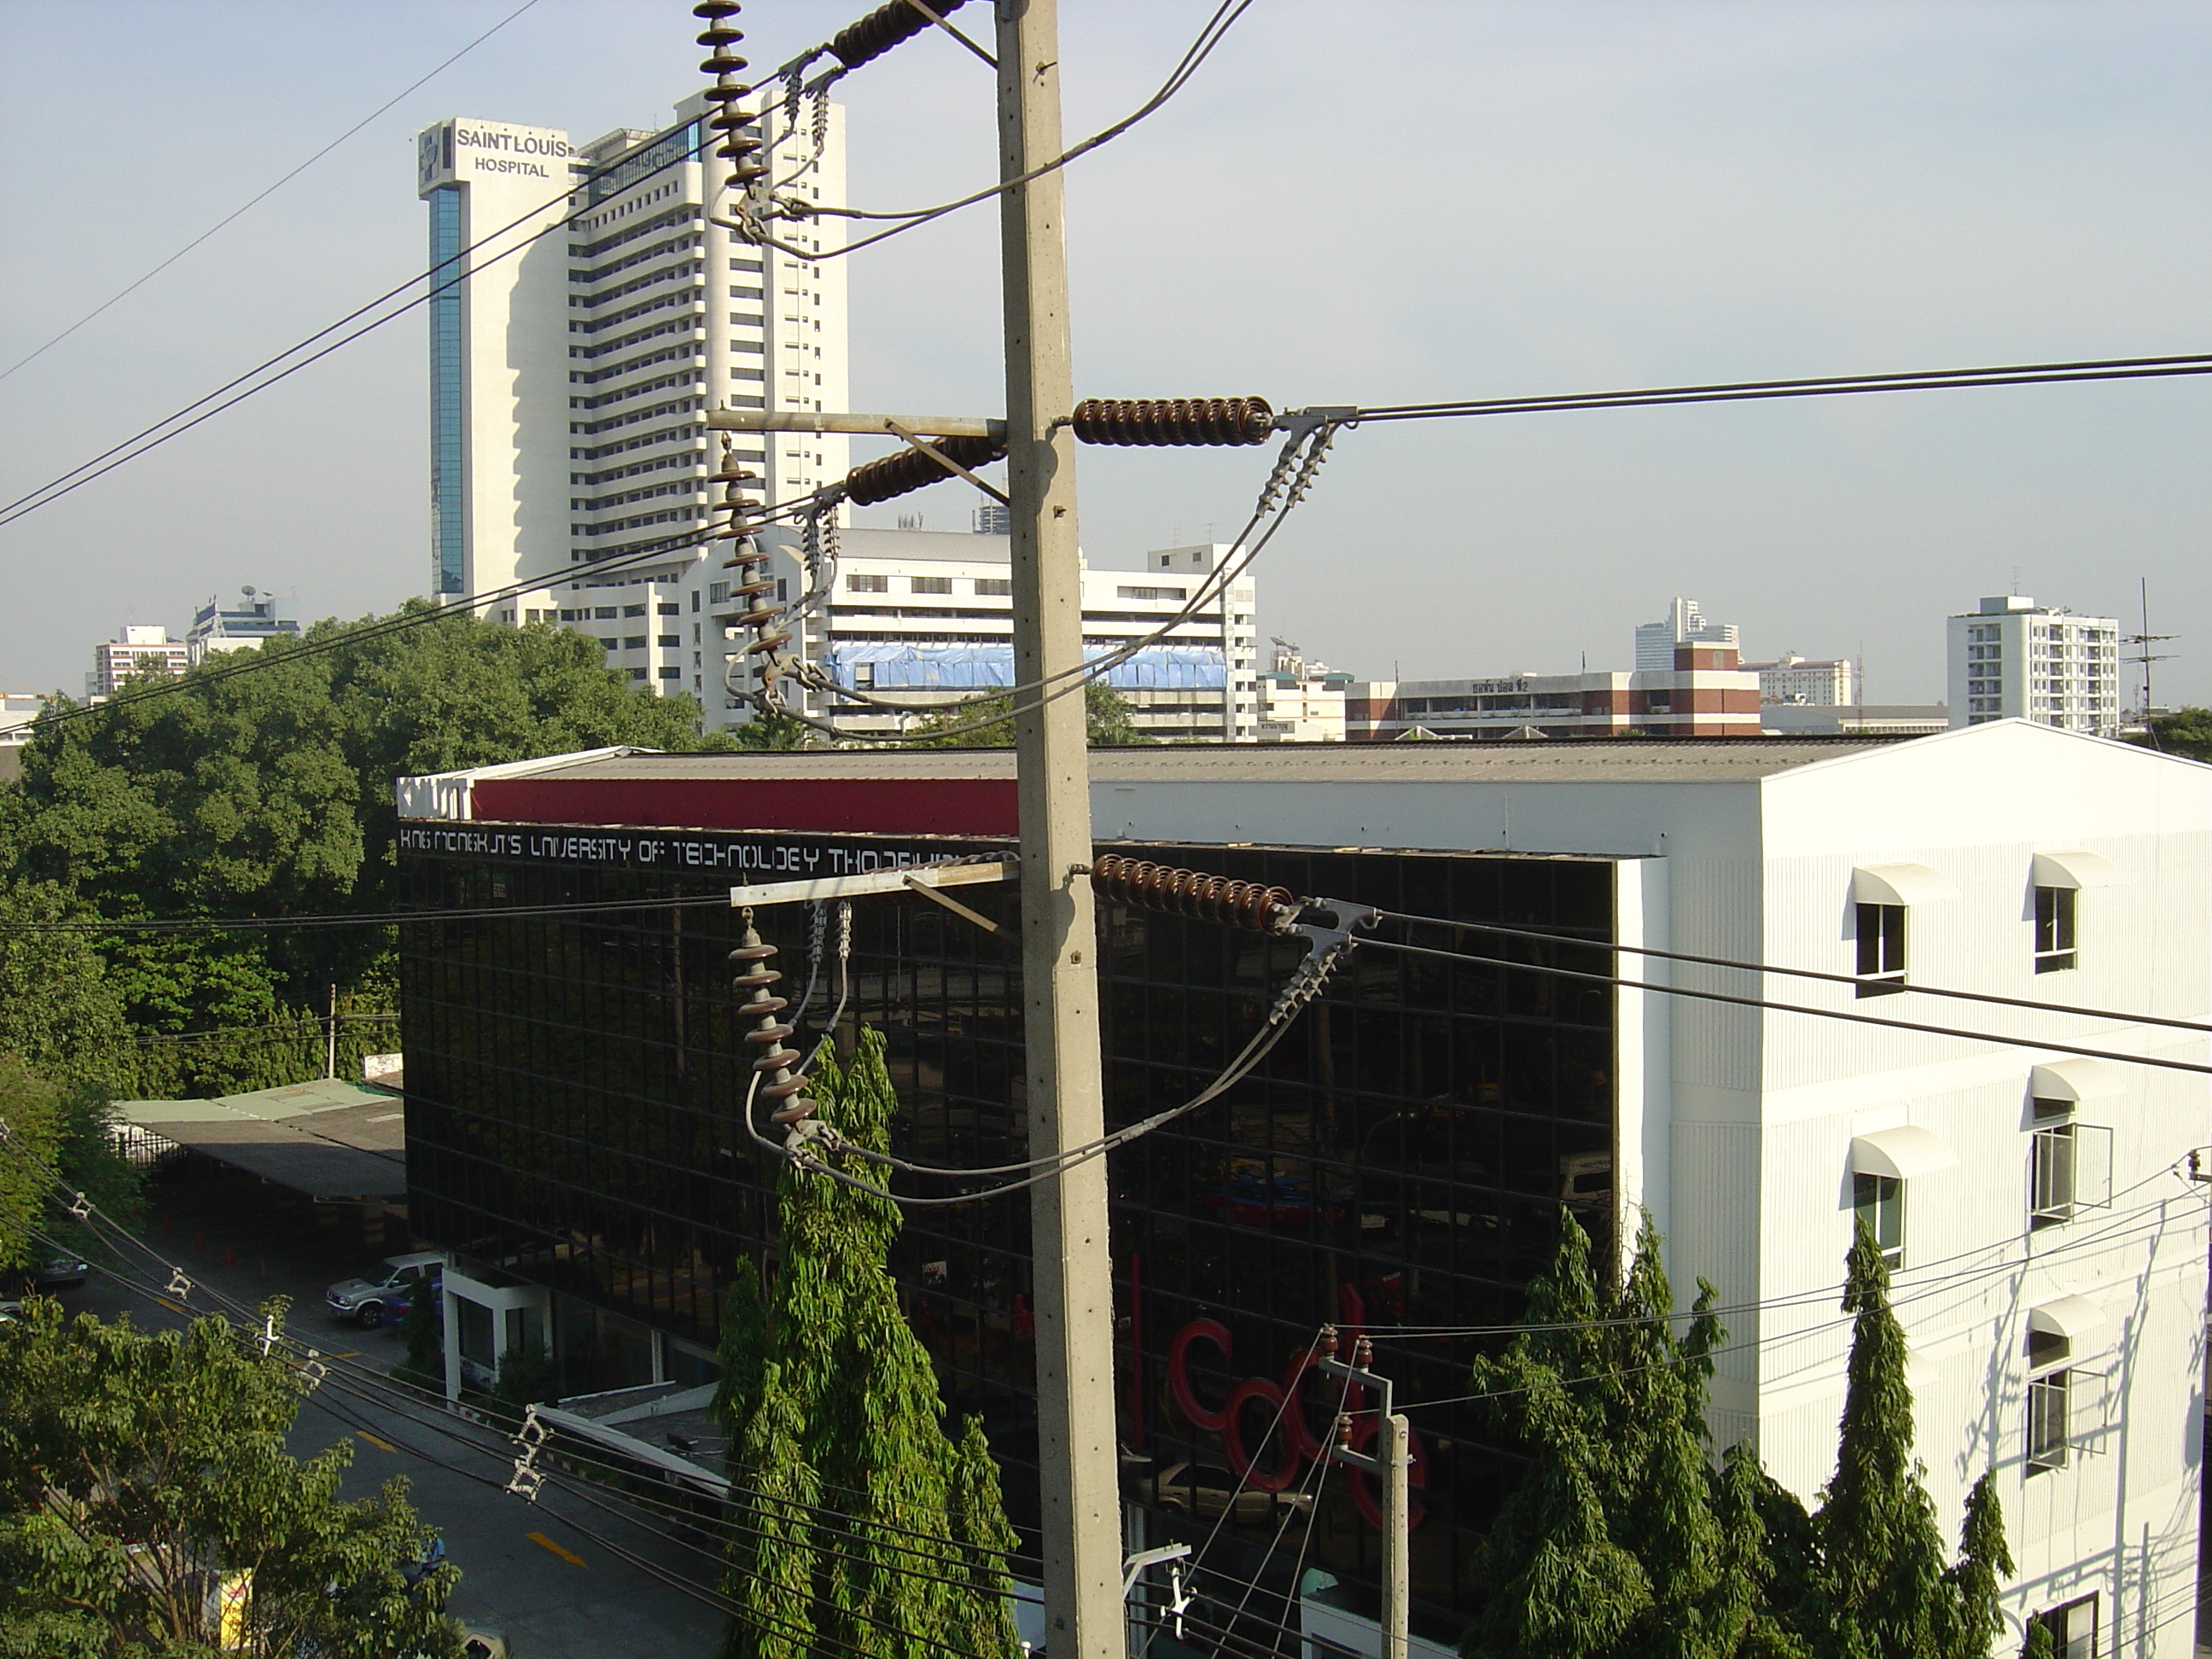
(416, 97, 1259, 741)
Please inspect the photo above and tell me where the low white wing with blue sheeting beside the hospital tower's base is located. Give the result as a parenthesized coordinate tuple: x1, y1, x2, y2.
(716, 528, 1259, 743)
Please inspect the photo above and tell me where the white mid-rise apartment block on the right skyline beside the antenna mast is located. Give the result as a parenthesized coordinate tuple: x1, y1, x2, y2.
(1944, 593, 2119, 736)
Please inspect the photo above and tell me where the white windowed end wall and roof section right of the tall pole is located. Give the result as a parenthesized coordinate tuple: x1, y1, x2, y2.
(1066, 721, 2212, 1659)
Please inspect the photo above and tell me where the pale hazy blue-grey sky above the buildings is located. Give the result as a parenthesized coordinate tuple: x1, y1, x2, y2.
(0, 0, 2212, 703)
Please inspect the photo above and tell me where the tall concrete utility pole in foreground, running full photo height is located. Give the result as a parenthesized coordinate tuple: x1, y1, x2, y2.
(998, 0, 1126, 1659)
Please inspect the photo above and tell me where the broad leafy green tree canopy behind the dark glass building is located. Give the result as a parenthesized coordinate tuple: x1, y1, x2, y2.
(0, 602, 725, 1095)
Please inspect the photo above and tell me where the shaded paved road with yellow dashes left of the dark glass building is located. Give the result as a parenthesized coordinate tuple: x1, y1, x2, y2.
(62, 1184, 724, 1659)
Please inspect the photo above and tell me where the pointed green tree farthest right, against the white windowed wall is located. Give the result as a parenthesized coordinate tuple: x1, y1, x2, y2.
(1802, 1221, 2013, 1659)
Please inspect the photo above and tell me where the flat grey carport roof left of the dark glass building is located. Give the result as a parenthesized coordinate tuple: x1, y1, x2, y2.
(115, 1080, 407, 1199)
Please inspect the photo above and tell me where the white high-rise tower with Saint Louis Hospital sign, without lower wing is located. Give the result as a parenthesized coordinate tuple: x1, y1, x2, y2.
(416, 95, 847, 725)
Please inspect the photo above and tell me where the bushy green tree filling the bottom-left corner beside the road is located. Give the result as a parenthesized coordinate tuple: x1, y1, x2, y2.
(0, 1299, 463, 1659)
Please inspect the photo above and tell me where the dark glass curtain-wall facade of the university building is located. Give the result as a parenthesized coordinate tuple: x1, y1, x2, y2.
(403, 825, 1615, 1637)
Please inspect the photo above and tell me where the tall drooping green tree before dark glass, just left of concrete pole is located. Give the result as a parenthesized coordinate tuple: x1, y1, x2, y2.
(719, 1031, 1020, 1659)
